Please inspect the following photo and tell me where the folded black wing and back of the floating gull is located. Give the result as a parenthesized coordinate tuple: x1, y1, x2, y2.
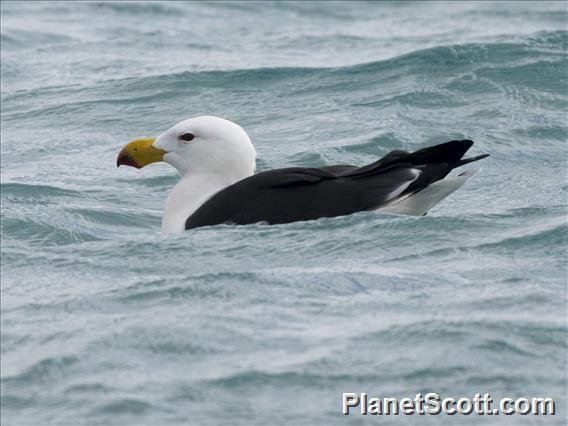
(185, 140, 485, 229)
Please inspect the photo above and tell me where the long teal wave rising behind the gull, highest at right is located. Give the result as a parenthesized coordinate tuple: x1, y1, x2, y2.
(2, 31, 568, 145)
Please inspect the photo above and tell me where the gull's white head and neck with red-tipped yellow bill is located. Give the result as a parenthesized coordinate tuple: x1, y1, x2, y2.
(117, 116, 256, 234)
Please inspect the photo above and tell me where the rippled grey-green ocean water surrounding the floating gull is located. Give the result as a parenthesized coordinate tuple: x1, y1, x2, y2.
(1, 2, 568, 425)
